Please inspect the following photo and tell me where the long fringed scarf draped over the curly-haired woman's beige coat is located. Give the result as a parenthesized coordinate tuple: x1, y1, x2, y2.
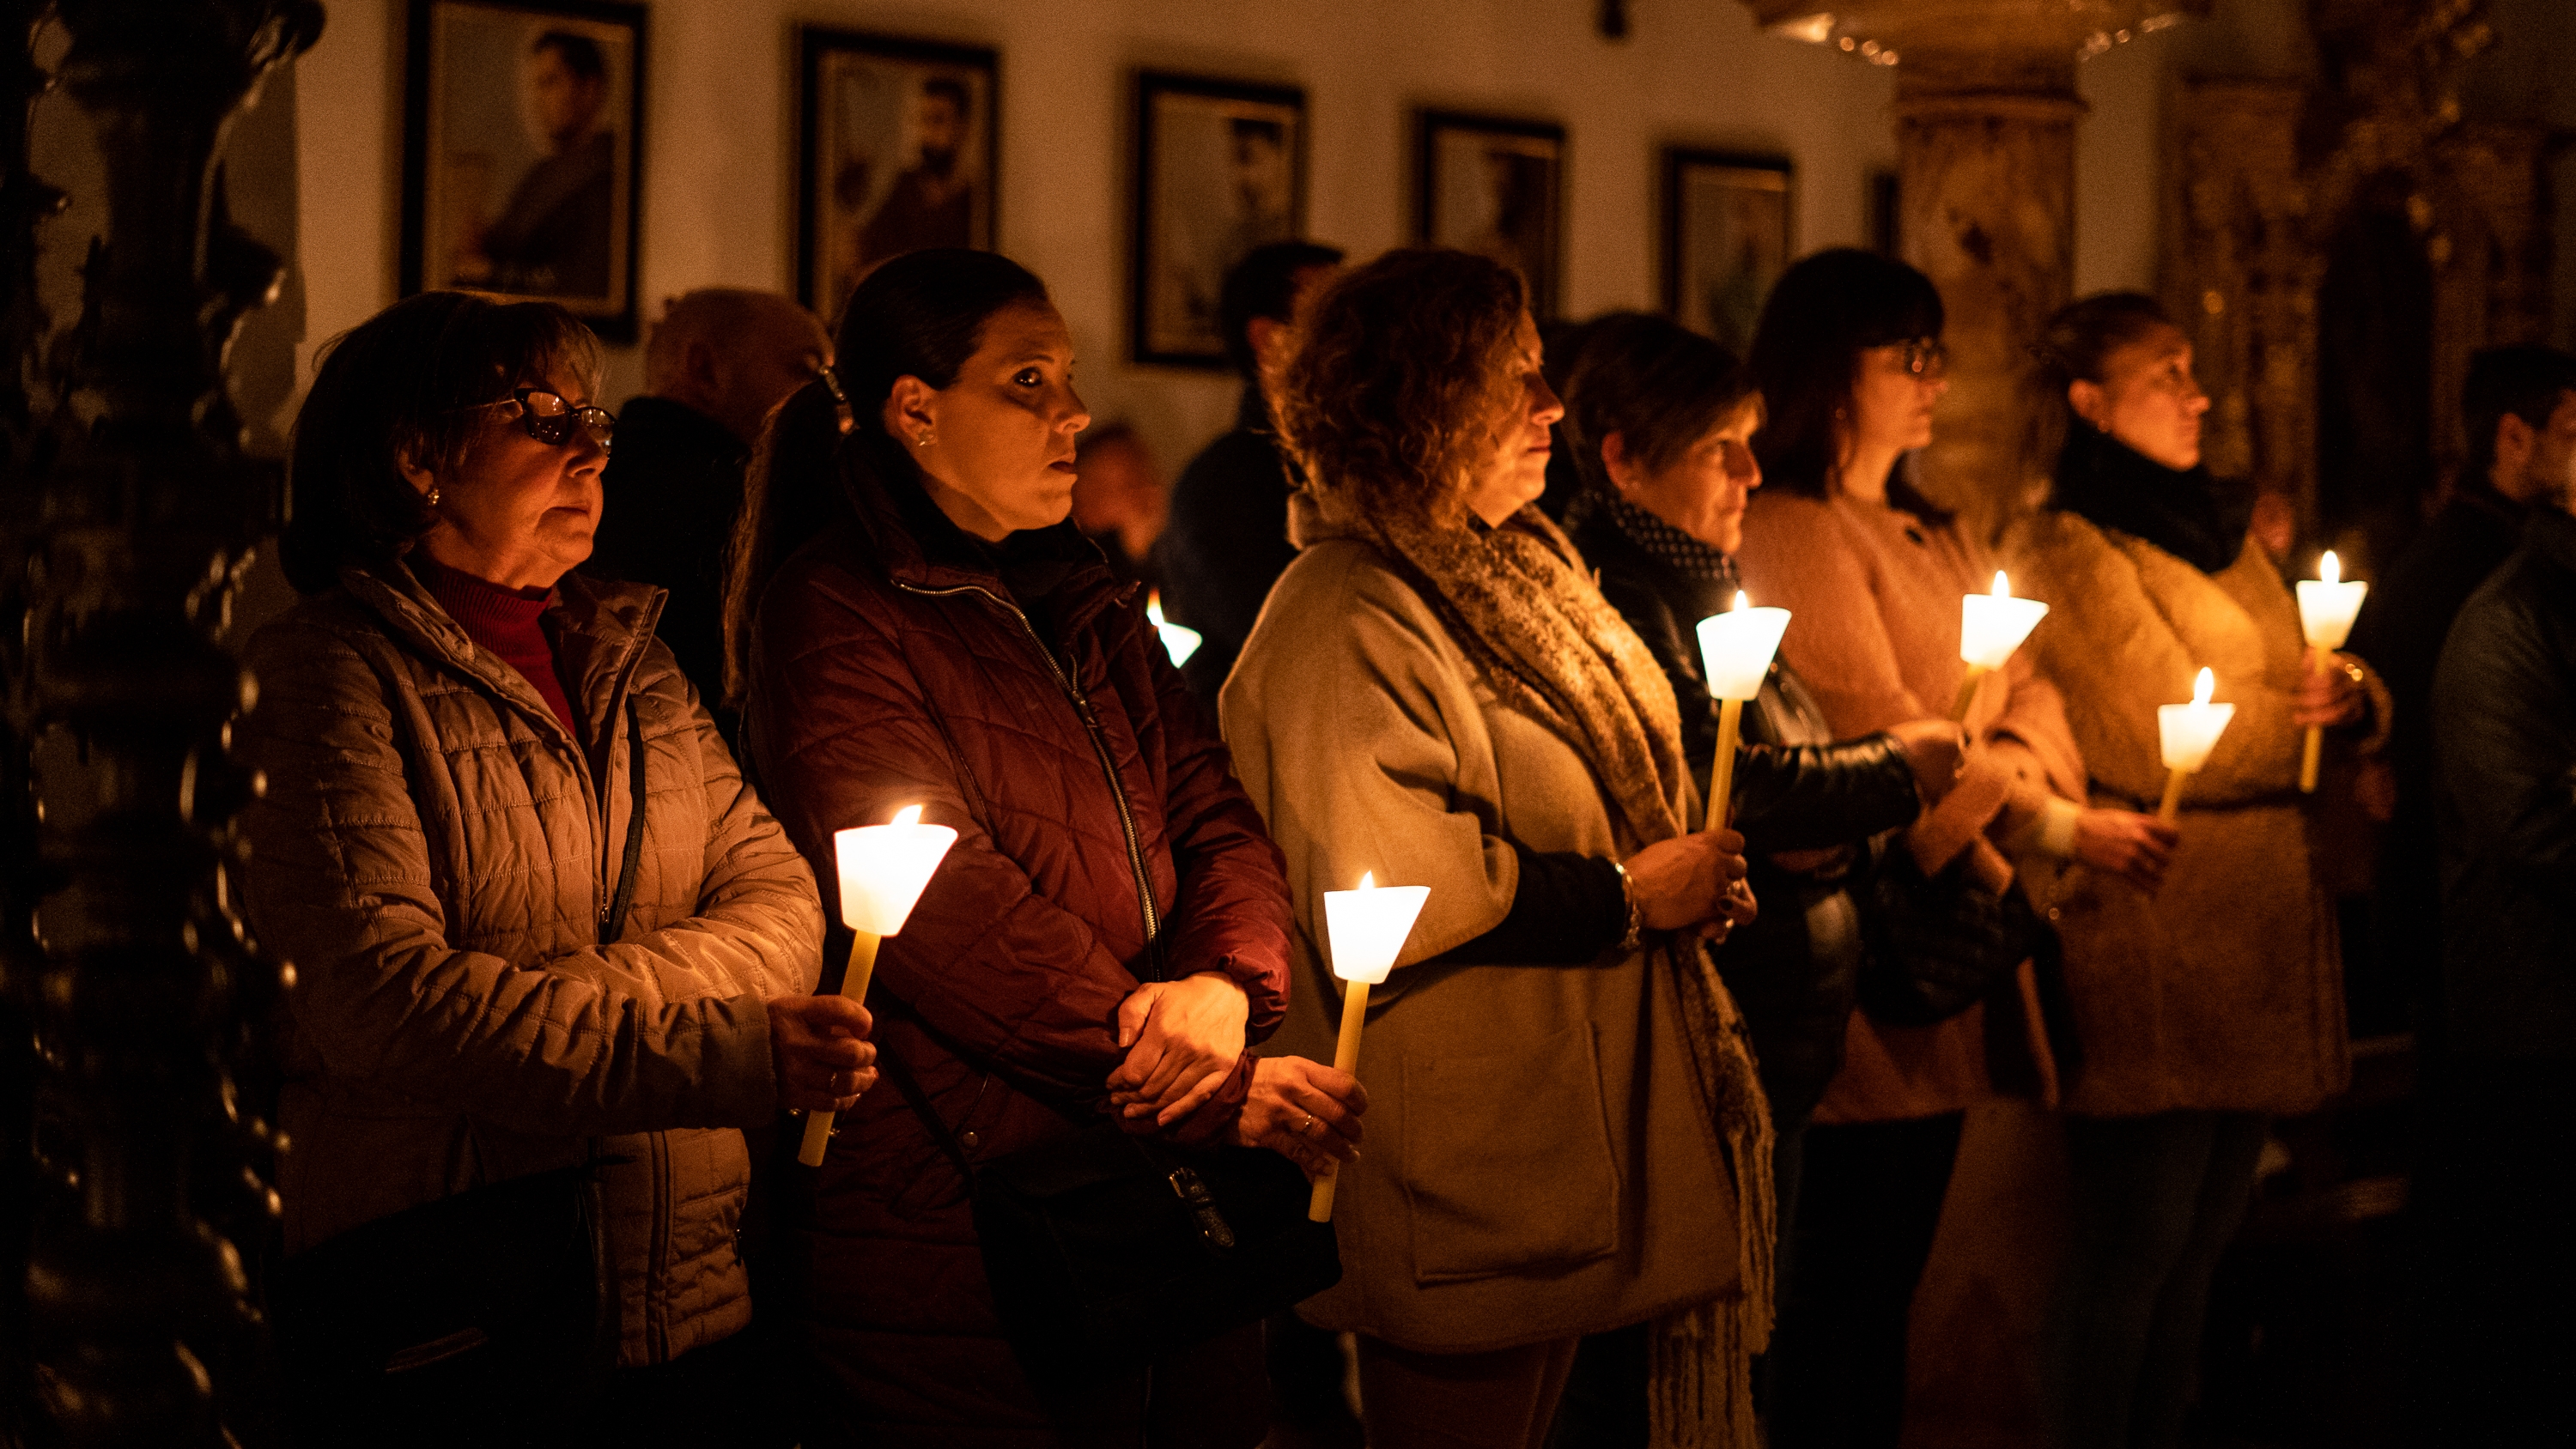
(1288, 487, 1777, 1449)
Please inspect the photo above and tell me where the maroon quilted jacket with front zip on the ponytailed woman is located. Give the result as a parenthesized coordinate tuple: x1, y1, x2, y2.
(744, 455, 1291, 1446)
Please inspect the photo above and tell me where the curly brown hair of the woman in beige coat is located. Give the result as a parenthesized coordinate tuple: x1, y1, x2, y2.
(1278, 247, 1530, 520)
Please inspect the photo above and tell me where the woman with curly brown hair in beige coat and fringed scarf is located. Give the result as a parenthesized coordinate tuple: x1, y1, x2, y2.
(1221, 250, 1770, 1449)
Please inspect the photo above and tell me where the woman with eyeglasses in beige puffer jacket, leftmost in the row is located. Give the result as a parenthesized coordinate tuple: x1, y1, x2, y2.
(242, 291, 855, 1444)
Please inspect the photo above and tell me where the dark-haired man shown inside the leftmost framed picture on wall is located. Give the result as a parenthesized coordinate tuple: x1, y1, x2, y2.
(482, 31, 618, 296)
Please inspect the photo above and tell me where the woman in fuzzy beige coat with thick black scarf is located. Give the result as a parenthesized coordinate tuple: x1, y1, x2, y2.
(2009, 294, 2388, 1449)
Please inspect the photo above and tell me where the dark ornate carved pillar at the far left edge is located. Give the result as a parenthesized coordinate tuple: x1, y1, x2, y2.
(0, 0, 322, 1446)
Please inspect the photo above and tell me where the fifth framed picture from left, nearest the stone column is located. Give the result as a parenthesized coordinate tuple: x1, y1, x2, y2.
(1664, 147, 1795, 358)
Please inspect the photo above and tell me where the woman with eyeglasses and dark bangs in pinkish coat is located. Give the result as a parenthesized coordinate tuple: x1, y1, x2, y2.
(1736, 250, 2174, 1449)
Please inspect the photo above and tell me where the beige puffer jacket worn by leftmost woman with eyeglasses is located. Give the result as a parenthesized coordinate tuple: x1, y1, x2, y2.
(242, 564, 822, 1364)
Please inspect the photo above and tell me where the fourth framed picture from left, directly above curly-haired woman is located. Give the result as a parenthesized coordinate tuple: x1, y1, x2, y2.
(1414, 111, 1566, 322)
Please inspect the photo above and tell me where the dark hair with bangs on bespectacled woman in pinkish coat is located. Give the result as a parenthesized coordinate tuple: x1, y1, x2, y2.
(1747, 247, 1942, 497)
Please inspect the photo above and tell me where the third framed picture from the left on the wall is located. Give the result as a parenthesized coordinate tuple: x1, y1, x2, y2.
(1128, 70, 1306, 368)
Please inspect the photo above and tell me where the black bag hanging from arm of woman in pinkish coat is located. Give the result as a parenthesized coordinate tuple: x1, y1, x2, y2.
(1860, 834, 2058, 1027)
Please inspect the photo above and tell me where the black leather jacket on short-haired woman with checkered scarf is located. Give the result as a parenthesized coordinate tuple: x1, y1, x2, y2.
(1574, 510, 1922, 1127)
